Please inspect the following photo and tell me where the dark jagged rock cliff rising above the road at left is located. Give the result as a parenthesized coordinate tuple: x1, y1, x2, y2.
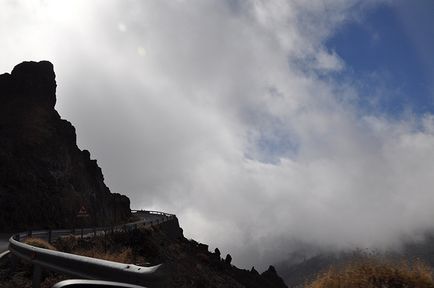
(0, 61, 130, 231)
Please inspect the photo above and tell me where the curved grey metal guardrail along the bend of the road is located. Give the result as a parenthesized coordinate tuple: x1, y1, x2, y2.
(9, 210, 175, 288)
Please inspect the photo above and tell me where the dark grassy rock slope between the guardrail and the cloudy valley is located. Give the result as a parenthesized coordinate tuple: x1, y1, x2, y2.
(62, 219, 286, 288)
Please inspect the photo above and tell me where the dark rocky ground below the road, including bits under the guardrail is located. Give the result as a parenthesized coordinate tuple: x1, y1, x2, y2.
(0, 219, 287, 288)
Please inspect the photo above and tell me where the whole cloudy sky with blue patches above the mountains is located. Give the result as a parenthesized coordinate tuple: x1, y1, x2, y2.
(0, 0, 434, 270)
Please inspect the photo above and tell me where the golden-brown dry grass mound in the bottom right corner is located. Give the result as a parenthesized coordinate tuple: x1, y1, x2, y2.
(305, 258, 434, 288)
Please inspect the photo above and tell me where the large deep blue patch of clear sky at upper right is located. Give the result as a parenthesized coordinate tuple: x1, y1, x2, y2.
(326, 0, 434, 117)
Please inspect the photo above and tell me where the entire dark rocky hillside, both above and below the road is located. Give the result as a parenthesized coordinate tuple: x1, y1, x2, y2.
(0, 61, 286, 288)
